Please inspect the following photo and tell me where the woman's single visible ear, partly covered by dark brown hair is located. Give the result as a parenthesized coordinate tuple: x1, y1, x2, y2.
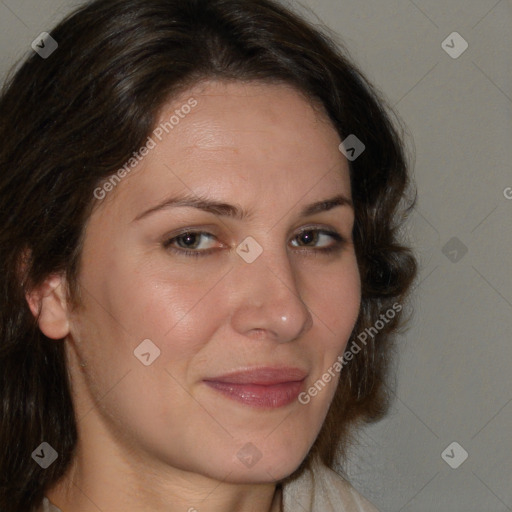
(25, 275, 69, 340)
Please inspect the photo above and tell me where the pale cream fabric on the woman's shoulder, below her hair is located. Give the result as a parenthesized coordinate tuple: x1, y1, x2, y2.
(283, 462, 379, 512)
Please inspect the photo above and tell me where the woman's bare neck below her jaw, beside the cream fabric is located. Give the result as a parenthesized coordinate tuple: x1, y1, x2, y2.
(46, 449, 282, 512)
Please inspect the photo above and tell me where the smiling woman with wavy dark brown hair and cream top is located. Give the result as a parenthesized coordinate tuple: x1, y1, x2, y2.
(0, 0, 416, 512)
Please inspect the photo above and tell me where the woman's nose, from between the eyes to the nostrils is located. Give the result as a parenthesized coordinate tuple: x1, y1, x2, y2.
(231, 244, 313, 343)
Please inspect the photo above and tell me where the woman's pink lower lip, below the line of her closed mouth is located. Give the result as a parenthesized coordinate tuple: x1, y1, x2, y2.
(205, 381, 303, 409)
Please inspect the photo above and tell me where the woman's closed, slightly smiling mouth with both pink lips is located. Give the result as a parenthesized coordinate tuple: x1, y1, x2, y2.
(203, 368, 307, 409)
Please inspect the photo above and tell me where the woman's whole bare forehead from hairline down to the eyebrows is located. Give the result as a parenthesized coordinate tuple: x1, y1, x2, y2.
(92, 82, 350, 219)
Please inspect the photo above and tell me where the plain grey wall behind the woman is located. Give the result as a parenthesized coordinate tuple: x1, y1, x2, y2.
(0, 0, 512, 512)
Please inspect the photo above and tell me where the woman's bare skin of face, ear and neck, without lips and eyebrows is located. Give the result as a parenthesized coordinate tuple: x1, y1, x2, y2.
(27, 81, 360, 512)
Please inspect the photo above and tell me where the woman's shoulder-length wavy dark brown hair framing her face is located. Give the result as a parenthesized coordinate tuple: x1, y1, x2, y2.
(0, 0, 416, 512)
